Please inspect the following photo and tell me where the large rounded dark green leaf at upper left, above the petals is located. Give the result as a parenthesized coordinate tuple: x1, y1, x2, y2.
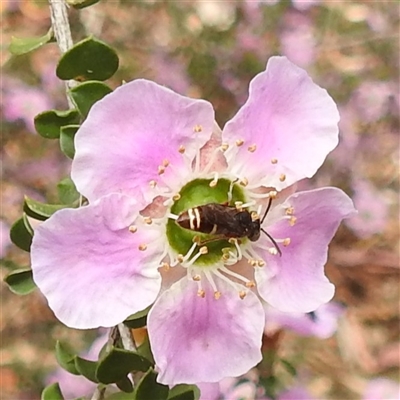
(56, 37, 119, 81)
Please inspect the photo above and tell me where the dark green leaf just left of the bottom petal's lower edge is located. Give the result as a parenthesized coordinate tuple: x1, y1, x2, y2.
(96, 347, 151, 384)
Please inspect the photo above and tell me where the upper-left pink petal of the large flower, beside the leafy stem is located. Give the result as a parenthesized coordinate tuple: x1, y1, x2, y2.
(72, 79, 214, 206)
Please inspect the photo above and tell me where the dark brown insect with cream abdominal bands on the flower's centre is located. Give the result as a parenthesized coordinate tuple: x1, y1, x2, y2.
(176, 198, 282, 255)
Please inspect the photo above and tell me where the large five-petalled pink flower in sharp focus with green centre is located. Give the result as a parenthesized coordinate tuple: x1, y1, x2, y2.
(32, 57, 354, 385)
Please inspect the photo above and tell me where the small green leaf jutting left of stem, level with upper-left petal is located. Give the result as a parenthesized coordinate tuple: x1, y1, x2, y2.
(34, 110, 79, 139)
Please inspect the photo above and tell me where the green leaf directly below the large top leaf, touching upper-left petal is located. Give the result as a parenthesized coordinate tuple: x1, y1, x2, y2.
(69, 81, 112, 118)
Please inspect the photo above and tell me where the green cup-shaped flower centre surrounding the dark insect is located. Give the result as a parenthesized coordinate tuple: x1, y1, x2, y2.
(167, 179, 246, 266)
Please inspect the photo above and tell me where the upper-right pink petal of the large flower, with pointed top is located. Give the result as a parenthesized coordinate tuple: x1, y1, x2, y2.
(222, 57, 339, 190)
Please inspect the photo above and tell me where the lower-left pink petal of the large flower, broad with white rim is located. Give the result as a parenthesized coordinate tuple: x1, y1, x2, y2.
(31, 194, 164, 329)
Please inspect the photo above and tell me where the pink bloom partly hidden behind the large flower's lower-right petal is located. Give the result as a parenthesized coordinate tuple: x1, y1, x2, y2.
(265, 302, 344, 339)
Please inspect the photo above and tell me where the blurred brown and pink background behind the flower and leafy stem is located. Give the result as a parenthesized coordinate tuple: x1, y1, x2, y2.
(0, 0, 400, 400)
